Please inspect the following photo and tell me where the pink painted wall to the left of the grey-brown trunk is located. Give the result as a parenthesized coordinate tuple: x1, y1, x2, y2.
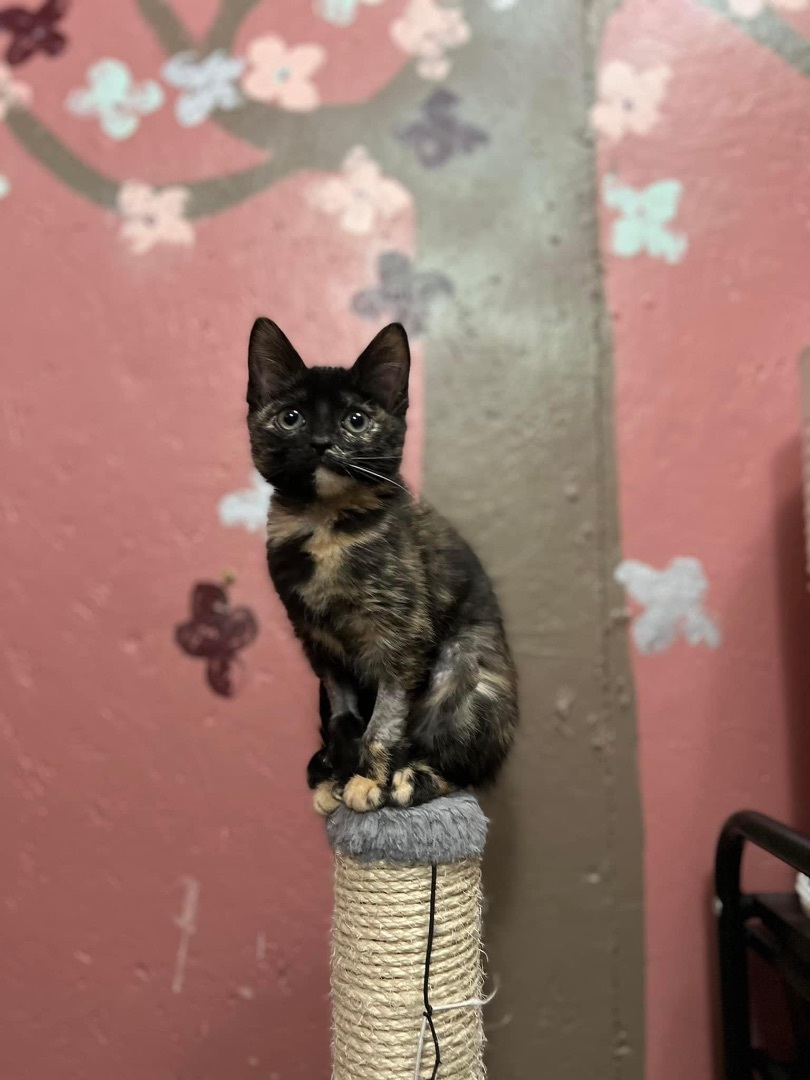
(0, 0, 421, 1080)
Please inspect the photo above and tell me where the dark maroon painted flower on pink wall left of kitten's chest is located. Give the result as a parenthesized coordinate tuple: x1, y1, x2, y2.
(174, 581, 259, 698)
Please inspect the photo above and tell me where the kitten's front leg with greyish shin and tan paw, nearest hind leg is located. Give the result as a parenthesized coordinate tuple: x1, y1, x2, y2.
(343, 685, 409, 813)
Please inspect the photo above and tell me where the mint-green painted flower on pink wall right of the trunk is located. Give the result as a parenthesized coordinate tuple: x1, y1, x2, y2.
(603, 176, 689, 262)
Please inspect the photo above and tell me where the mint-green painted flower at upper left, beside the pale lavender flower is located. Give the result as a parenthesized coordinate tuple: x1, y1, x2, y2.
(65, 59, 163, 139)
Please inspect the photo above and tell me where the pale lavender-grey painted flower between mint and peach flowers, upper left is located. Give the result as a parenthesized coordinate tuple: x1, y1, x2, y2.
(163, 49, 245, 127)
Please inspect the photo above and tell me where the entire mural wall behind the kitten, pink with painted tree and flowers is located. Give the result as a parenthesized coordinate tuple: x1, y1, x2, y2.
(0, 0, 810, 1080)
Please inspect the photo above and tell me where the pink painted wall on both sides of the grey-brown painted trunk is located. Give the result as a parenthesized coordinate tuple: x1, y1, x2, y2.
(6, 0, 810, 1080)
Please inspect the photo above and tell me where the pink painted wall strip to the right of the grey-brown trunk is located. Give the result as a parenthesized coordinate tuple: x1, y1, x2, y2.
(594, 0, 810, 1080)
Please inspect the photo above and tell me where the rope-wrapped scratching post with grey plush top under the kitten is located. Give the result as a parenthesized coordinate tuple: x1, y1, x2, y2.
(327, 794, 487, 1080)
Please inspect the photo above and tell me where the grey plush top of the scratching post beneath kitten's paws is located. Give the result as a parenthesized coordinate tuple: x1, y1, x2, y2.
(326, 792, 488, 865)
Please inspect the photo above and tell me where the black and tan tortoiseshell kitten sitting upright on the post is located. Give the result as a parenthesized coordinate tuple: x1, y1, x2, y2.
(247, 319, 517, 814)
